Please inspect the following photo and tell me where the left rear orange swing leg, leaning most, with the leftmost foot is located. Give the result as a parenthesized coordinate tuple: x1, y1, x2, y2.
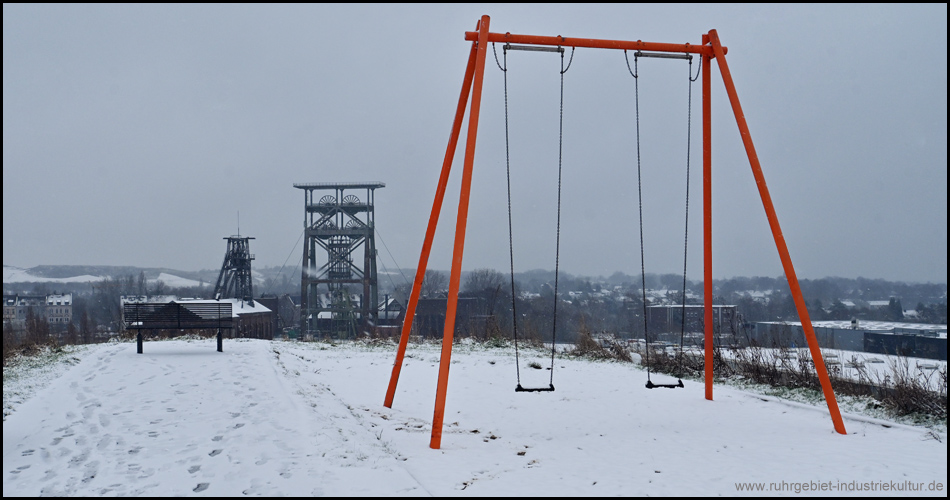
(383, 42, 476, 408)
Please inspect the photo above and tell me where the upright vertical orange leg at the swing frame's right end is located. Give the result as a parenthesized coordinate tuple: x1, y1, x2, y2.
(702, 35, 714, 401)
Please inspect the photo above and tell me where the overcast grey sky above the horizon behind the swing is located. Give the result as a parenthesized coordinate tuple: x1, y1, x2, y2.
(3, 4, 947, 283)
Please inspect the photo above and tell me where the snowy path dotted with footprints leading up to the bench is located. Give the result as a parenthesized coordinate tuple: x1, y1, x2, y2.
(3, 341, 419, 496)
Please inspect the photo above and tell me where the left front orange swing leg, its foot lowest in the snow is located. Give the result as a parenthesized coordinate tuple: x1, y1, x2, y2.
(429, 16, 489, 449)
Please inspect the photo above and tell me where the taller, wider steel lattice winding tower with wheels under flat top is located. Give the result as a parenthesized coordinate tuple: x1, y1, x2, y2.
(294, 182, 386, 338)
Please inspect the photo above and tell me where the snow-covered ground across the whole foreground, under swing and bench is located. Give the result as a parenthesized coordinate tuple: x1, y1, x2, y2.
(3, 340, 947, 497)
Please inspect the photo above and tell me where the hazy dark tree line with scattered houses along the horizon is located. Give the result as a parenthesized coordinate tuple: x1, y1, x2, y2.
(4, 268, 947, 364)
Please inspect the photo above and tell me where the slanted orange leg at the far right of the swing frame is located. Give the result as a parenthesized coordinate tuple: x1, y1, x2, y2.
(709, 30, 847, 434)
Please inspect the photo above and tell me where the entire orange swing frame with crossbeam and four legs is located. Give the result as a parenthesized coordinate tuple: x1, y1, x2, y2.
(383, 15, 847, 449)
